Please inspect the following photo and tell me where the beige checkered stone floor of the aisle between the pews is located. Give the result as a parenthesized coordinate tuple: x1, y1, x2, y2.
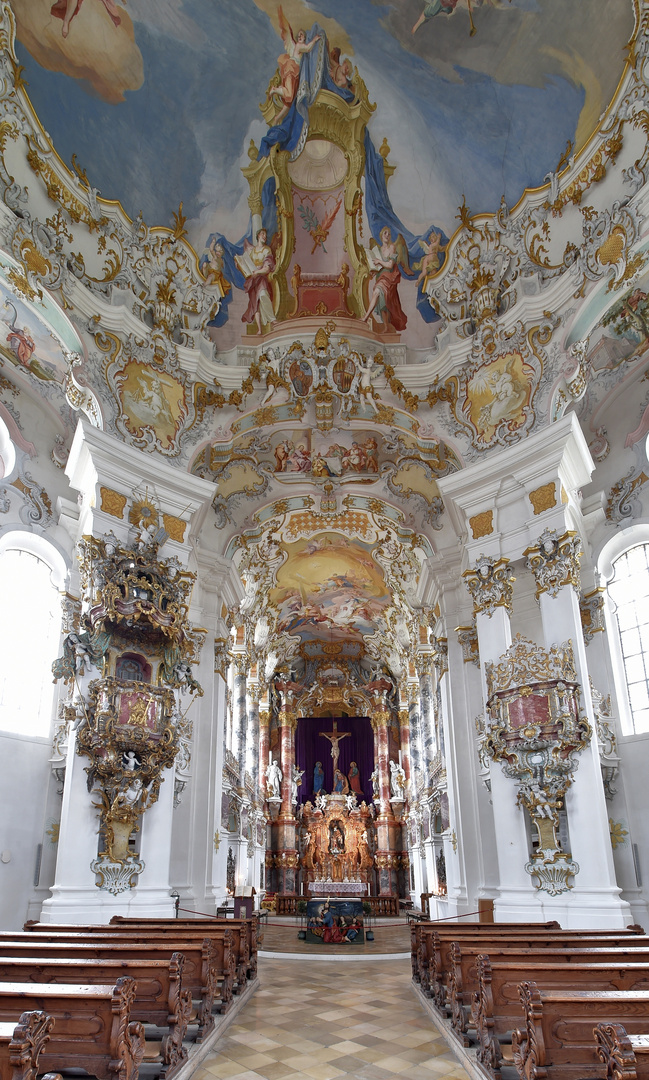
(192, 957, 468, 1080)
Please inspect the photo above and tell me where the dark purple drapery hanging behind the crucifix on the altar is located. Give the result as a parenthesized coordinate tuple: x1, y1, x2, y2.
(295, 716, 374, 804)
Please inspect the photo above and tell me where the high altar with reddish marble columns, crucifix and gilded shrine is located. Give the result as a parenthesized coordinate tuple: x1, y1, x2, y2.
(267, 681, 409, 897)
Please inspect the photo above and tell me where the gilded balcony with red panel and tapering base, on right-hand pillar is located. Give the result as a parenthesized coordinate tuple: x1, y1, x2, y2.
(482, 634, 593, 896)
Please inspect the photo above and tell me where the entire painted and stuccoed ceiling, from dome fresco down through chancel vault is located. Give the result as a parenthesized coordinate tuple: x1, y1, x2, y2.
(0, 0, 649, 677)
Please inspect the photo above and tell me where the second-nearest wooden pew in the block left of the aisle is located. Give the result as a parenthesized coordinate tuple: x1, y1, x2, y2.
(0, 976, 145, 1080)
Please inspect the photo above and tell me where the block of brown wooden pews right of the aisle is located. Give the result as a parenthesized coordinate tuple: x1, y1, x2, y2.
(410, 922, 649, 1080)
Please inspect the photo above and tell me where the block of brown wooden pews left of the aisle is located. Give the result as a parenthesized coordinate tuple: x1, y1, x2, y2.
(0, 916, 258, 1080)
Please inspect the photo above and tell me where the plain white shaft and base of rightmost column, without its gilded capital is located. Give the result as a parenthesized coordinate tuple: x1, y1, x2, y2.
(539, 584, 631, 927)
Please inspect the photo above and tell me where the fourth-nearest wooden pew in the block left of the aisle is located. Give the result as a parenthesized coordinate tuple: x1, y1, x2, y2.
(0, 931, 225, 1042)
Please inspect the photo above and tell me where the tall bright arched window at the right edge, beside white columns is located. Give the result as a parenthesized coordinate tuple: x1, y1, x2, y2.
(608, 542, 649, 734)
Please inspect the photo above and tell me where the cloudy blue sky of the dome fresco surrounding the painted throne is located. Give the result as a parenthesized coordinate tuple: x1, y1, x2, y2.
(13, 0, 633, 265)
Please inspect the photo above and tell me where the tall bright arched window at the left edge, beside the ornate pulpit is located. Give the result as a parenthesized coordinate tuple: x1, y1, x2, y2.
(0, 534, 65, 737)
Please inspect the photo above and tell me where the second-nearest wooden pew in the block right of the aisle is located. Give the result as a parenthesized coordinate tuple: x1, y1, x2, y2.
(512, 982, 649, 1080)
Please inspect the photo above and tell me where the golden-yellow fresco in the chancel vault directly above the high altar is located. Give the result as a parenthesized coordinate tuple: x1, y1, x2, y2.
(270, 534, 390, 642)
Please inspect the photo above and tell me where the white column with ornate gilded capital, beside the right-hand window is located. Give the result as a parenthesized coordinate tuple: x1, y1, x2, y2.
(525, 529, 630, 927)
